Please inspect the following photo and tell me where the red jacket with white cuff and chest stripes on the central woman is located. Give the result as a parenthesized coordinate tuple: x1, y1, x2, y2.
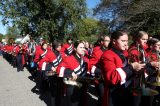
(57, 54, 88, 77)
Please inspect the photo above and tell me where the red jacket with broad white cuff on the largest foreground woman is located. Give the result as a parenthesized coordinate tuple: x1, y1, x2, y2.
(100, 48, 133, 106)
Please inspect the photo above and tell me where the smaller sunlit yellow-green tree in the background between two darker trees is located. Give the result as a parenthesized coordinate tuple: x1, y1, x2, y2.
(74, 17, 109, 42)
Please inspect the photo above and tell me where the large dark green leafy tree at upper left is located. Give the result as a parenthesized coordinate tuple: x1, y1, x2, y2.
(0, 0, 87, 41)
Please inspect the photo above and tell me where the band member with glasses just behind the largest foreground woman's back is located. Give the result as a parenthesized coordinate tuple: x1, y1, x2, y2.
(89, 36, 110, 106)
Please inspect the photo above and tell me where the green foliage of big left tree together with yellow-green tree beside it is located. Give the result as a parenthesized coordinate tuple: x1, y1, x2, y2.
(0, 0, 112, 42)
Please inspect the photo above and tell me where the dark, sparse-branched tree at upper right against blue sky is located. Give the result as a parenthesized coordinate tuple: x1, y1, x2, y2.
(94, 0, 160, 34)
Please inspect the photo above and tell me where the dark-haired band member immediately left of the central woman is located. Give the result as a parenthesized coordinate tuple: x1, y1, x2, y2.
(39, 42, 63, 106)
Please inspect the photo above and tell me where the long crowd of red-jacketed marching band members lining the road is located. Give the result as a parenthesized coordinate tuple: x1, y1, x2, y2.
(0, 31, 160, 106)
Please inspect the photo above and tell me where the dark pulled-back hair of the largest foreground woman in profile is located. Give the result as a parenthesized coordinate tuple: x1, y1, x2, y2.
(108, 30, 128, 48)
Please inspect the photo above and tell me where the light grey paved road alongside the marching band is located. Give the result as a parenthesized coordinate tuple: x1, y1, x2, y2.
(0, 56, 47, 106)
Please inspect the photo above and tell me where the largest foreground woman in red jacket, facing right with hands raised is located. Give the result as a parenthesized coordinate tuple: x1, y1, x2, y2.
(100, 31, 145, 106)
